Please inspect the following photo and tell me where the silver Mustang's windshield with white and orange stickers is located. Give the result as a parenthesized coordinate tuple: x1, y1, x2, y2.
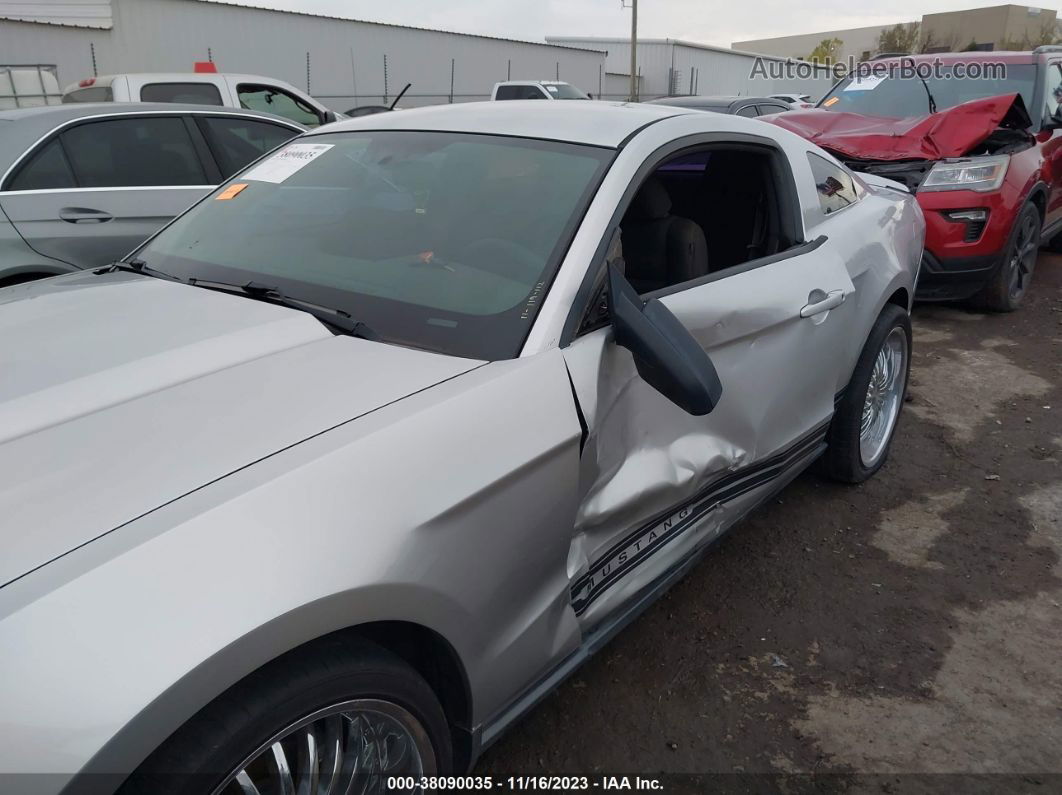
(136, 131, 612, 360)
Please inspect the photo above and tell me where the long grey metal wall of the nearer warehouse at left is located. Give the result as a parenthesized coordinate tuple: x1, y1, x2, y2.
(0, 0, 604, 110)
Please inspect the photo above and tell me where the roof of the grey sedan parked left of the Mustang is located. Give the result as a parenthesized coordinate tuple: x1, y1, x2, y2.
(0, 102, 305, 172)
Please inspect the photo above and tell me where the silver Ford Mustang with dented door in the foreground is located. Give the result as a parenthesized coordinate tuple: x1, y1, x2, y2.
(0, 102, 924, 795)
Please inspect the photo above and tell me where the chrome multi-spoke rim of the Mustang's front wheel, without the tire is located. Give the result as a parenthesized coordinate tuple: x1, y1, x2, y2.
(213, 698, 436, 795)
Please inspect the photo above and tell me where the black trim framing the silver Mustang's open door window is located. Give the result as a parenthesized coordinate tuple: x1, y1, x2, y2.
(558, 133, 807, 348)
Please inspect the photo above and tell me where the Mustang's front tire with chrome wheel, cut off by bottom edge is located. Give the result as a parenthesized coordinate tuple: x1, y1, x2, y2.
(119, 635, 452, 795)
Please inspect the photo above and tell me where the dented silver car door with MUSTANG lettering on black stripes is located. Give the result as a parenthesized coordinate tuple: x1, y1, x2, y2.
(563, 137, 855, 629)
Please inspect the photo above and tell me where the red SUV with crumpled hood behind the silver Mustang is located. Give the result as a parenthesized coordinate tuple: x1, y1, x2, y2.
(774, 47, 1062, 312)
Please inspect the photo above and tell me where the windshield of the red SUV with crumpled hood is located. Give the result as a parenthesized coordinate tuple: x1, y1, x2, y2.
(819, 64, 1037, 119)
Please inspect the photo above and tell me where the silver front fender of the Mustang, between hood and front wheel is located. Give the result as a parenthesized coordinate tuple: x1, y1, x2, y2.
(0, 350, 581, 792)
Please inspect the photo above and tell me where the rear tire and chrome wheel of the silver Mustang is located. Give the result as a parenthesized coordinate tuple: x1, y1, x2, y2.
(821, 304, 911, 483)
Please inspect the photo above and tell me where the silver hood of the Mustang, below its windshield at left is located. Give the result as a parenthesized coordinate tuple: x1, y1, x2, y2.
(0, 272, 480, 586)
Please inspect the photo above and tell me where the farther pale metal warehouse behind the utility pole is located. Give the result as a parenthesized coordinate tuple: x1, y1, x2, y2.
(546, 36, 834, 100)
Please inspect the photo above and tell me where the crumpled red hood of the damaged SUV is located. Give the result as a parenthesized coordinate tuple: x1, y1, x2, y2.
(768, 93, 1032, 160)
